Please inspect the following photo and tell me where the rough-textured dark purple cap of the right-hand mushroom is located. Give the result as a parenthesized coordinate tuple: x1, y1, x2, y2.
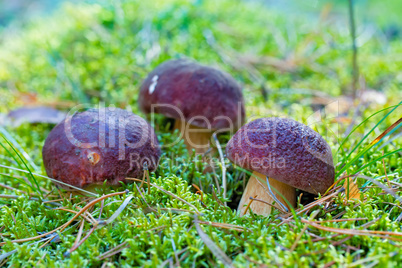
(226, 117, 335, 194)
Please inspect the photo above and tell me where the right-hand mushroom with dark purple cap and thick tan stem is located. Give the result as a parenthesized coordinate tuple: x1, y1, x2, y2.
(226, 117, 335, 216)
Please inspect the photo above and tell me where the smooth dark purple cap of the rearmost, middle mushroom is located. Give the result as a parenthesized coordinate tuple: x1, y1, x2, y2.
(138, 59, 244, 129)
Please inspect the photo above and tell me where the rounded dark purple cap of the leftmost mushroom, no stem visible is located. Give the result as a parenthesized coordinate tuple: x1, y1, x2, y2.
(42, 108, 161, 188)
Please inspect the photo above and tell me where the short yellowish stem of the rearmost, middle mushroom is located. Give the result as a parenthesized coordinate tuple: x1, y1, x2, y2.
(174, 120, 212, 154)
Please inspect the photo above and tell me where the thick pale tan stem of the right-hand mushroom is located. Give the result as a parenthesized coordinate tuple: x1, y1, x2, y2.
(237, 171, 296, 216)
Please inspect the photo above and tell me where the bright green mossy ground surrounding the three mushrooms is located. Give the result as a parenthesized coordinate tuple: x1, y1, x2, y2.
(0, 0, 402, 267)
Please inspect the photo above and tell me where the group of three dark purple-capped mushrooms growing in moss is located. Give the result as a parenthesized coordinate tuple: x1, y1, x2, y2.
(42, 59, 334, 215)
